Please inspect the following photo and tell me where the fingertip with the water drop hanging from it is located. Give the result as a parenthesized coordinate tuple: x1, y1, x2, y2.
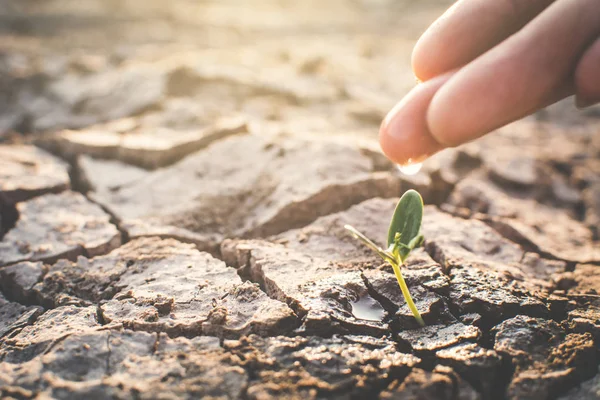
(379, 72, 454, 165)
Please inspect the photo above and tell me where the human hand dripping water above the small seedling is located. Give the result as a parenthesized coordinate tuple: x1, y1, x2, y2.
(379, 0, 600, 164)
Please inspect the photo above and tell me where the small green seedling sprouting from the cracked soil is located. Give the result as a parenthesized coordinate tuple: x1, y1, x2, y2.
(344, 190, 425, 326)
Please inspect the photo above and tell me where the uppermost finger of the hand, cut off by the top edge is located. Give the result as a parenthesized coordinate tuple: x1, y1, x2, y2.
(412, 0, 554, 81)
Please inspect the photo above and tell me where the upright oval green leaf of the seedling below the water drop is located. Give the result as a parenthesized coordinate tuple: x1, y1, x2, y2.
(387, 189, 423, 262)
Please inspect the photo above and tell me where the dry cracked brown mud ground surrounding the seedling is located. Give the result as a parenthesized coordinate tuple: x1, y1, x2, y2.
(0, 0, 600, 400)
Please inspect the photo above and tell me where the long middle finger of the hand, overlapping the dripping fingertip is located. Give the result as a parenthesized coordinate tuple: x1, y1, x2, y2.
(427, 0, 600, 146)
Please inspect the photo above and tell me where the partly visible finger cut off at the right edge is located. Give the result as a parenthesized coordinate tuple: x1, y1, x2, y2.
(575, 38, 600, 108)
